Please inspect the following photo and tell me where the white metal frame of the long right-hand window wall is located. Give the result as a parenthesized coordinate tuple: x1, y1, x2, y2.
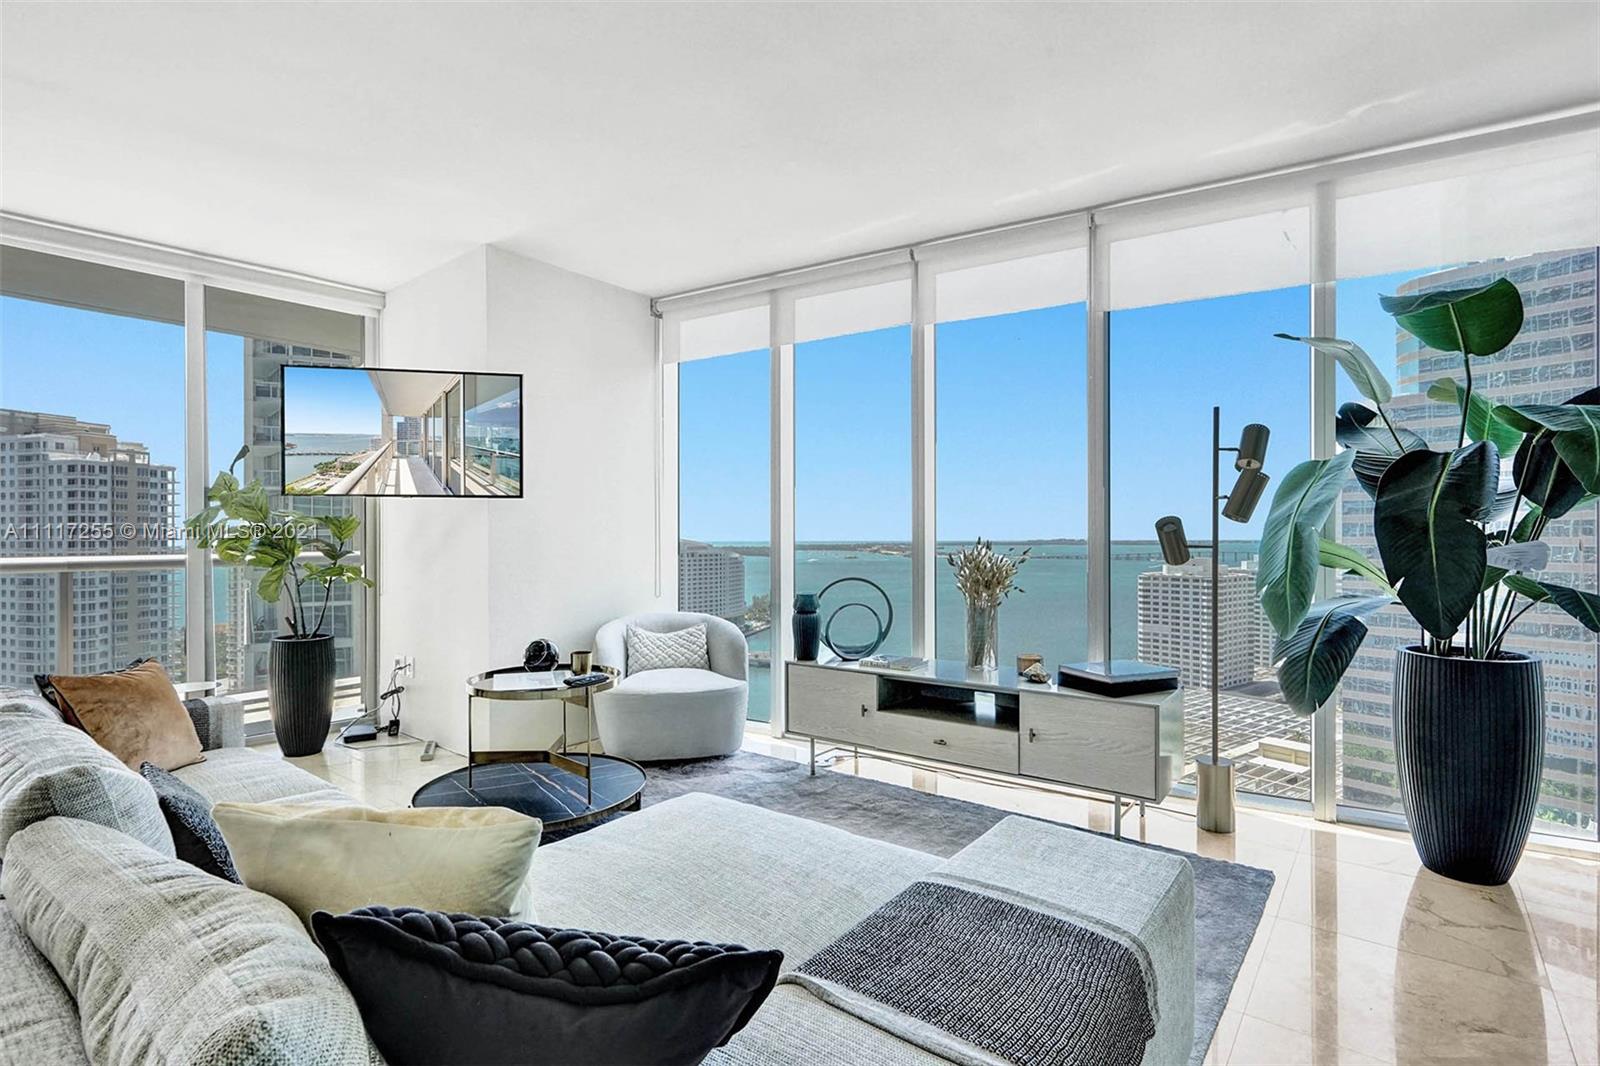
(653, 114, 1600, 847)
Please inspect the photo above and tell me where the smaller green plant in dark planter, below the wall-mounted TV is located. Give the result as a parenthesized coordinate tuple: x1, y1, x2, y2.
(184, 445, 373, 757)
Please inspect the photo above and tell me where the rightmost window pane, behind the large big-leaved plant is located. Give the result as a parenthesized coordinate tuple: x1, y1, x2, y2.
(1338, 143, 1600, 837)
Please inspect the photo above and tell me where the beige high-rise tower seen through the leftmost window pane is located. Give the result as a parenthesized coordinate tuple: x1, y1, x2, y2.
(0, 408, 184, 685)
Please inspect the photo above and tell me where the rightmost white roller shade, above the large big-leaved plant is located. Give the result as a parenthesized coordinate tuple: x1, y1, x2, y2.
(1338, 134, 1600, 277)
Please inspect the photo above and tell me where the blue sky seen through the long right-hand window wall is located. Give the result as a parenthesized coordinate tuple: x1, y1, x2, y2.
(678, 272, 1414, 541)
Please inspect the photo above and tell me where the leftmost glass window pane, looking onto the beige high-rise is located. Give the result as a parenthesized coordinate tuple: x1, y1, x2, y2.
(0, 248, 194, 685)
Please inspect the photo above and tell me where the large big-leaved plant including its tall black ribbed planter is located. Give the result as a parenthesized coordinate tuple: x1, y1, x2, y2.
(1256, 279, 1600, 885)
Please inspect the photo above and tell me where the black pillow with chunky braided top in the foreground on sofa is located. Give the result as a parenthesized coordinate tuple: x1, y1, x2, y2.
(310, 906, 784, 1066)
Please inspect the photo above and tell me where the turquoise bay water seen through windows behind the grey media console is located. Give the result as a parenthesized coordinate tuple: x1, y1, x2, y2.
(720, 541, 1256, 722)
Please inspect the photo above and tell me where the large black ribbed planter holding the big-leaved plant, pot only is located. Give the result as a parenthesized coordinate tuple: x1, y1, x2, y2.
(1394, 647, 1544, 885)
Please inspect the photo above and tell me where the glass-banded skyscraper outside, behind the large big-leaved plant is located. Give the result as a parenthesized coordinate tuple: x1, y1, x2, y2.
(1339, 248, 1600, 832)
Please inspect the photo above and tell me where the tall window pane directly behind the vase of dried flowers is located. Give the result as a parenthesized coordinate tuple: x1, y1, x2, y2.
(923, 240, 1088, 669)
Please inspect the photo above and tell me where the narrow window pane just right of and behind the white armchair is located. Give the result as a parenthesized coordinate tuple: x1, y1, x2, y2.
(667, 299, 774, 722)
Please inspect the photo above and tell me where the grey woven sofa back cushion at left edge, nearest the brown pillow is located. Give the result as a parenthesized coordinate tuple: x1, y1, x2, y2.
(0, 714, 174, 855)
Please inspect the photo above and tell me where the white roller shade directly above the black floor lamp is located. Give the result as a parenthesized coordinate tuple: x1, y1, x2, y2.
(1106, 205, 1310, 311)
